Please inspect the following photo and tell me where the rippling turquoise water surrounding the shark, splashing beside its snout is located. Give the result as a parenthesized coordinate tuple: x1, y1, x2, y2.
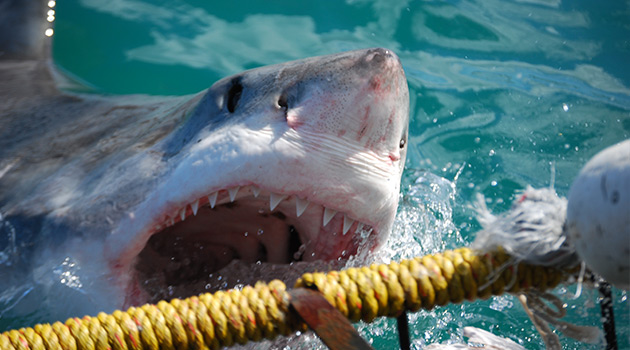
(30, 0, 630, 349)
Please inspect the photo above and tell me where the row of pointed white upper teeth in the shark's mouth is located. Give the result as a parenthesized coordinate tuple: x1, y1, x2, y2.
(166, 186, 364, 235)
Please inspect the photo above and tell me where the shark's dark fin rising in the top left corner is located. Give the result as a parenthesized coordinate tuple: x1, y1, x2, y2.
(0, 0, 52, 60)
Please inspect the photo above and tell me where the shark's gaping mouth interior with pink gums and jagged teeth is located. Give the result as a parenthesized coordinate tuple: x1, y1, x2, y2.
(127, 185, 377, 304)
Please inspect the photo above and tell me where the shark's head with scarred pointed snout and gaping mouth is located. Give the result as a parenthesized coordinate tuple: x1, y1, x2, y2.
(108, 49, 409, 304)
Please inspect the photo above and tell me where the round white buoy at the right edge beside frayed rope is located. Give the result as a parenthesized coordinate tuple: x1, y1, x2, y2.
(567, 140, 630, 290)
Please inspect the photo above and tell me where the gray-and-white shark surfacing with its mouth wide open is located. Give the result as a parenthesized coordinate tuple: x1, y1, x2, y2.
(0, 1, 409, 322)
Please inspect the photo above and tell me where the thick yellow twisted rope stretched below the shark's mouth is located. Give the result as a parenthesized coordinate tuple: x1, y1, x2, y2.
(0, 248, 573, 350)
